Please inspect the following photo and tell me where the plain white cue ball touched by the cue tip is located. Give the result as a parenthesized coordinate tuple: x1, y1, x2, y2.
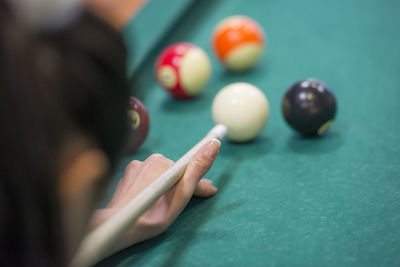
(211, 82, 269, 142)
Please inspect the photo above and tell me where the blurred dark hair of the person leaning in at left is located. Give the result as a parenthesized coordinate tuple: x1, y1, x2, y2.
(0, 1, 129, 266)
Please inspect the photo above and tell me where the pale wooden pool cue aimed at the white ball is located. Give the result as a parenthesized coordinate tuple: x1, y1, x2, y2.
(70, 124, 227, 267)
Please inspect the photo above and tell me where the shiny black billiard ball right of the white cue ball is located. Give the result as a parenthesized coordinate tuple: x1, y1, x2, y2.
(282, 79, 336, 136)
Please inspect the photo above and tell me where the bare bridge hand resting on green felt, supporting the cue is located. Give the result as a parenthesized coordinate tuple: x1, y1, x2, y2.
(91, 139, 221, 254)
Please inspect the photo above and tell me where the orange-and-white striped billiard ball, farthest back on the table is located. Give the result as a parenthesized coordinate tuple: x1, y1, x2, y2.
(212, 16, 266, 72)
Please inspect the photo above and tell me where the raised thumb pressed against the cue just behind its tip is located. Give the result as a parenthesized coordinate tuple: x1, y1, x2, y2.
(184, 138, 221, 186)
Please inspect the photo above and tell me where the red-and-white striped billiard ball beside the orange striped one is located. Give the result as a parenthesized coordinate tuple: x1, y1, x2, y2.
(156, 43, 211, 99)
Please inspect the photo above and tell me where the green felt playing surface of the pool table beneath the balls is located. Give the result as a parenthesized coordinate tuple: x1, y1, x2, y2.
(96, 0, 400, 266)
